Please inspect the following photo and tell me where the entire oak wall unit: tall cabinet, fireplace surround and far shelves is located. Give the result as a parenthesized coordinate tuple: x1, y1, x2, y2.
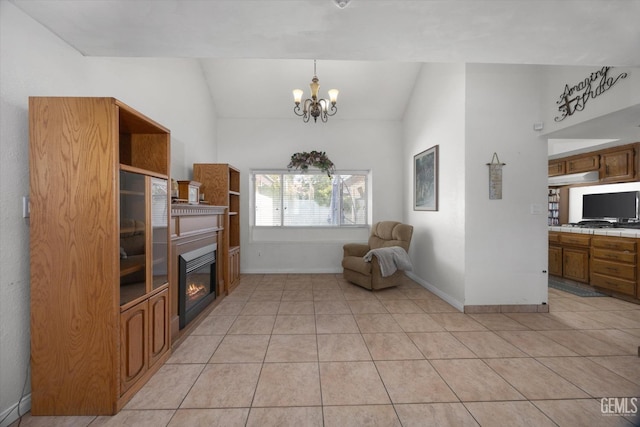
(29, 97, 240, 415)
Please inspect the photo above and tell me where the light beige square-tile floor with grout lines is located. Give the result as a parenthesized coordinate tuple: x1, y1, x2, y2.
(14, 274, 640, 427)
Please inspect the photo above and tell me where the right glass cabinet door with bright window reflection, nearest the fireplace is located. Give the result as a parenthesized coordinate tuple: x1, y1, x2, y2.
(150, 178, 169, 289)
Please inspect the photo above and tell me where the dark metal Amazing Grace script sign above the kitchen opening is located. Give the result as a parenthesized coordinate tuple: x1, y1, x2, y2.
(554, 67, 627, 122)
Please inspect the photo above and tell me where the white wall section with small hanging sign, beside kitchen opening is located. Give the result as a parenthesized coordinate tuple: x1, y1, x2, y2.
(464, 65, 548, 305)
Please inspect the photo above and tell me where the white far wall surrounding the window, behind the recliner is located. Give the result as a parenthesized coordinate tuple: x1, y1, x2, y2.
(218, 117, 403, 273)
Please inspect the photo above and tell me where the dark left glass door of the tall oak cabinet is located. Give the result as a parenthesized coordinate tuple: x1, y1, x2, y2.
(120, 171, 147, 305)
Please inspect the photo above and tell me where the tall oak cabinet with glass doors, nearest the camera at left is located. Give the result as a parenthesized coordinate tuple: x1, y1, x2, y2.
(29, 97, 171, 415)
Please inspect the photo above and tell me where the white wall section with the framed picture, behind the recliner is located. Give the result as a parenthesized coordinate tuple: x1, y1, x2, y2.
(402, 64, 467, 308)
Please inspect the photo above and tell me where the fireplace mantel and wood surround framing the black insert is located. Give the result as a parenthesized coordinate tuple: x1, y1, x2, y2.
(170, 203, 227, 344)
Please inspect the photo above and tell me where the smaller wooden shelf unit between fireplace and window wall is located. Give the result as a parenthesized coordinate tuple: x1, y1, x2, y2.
(193, 163, 240, 293)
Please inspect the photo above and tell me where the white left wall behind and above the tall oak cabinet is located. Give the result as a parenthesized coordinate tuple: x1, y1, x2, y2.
(0, 0, 216, 426)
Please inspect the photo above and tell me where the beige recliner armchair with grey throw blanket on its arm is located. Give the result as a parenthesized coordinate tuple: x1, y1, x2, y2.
(342, 221, 413, 290)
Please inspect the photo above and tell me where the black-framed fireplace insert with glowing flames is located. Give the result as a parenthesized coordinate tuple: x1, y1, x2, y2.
(178, 244, 217, 329)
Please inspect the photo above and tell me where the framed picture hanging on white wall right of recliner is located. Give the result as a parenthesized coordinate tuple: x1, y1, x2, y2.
(413, 145, 438, 211)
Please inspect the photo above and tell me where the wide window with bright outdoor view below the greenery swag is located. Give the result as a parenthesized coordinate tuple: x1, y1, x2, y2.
(252, 171, 369, 227)
